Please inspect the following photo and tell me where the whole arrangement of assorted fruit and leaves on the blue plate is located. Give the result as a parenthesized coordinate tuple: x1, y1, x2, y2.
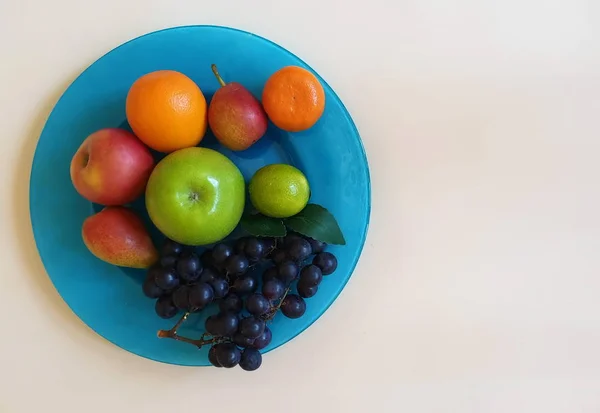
(70, 65, 345, 371)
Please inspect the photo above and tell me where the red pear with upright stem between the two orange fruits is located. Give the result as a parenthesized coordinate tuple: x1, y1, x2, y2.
(208, 65, 268, 151)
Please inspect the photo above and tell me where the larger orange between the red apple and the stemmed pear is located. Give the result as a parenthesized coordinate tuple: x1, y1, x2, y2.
(125, 70, 206, 152)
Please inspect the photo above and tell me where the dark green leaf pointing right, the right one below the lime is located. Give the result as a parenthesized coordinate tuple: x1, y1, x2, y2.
(285, 204, 346, 245)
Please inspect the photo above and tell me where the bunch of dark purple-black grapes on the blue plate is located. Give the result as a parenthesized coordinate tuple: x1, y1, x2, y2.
(144, 234, 337, 371)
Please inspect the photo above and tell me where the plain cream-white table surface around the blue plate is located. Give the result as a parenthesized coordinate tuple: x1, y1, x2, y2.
(0, 0, 600, 413)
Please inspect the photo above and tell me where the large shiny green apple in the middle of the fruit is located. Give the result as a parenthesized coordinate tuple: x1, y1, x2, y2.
(146, 147, 245, 245)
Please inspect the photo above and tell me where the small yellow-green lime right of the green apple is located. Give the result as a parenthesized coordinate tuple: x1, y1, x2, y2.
(248, 163, 310, 218)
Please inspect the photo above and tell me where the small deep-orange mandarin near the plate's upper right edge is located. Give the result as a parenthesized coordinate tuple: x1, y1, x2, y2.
(262, 66, 325, 132)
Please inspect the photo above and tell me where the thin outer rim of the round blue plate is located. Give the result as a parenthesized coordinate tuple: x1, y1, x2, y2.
(28, 24, 372, 368)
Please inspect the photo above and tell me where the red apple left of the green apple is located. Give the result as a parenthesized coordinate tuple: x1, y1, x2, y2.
(71, 128, 154, 205)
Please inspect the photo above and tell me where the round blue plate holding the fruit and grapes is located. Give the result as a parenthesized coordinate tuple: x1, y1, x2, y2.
(30, 26, 370, 366)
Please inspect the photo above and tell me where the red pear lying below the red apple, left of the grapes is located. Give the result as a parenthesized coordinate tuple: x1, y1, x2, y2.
(81, 206, 158, 268)
